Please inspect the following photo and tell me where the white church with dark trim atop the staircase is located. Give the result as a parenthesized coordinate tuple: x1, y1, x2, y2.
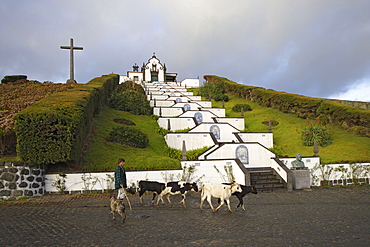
(127, 53, 177, 82)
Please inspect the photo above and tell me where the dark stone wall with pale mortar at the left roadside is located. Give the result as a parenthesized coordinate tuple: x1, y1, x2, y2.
(0, 162, 45, 199)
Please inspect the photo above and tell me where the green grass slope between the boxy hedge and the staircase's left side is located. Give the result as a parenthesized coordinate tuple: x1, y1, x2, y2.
(81, 107, 180, 172)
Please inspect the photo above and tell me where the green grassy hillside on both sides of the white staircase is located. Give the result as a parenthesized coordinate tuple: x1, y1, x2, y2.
(0, 78, 370, 172)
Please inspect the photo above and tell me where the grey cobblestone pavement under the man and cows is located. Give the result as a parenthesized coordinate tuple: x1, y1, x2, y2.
(0, 186, 370, 246)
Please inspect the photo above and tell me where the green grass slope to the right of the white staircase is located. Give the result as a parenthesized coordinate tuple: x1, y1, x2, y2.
(212, 96, 370, 163)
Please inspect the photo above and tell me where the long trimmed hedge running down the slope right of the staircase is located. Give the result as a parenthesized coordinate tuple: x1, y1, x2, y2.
(204, 75, 370, 137)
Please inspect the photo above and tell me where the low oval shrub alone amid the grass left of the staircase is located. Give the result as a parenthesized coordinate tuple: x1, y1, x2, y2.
(108, 126, 149, 148)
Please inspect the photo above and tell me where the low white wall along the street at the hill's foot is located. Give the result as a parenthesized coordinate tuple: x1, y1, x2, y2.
(45, 162, 370, 193)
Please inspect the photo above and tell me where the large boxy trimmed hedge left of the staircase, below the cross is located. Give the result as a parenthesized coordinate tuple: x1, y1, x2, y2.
(14, 74, 119, 164)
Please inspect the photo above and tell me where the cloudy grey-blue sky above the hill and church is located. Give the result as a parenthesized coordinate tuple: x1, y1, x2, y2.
(0, 0, 370, 101)
